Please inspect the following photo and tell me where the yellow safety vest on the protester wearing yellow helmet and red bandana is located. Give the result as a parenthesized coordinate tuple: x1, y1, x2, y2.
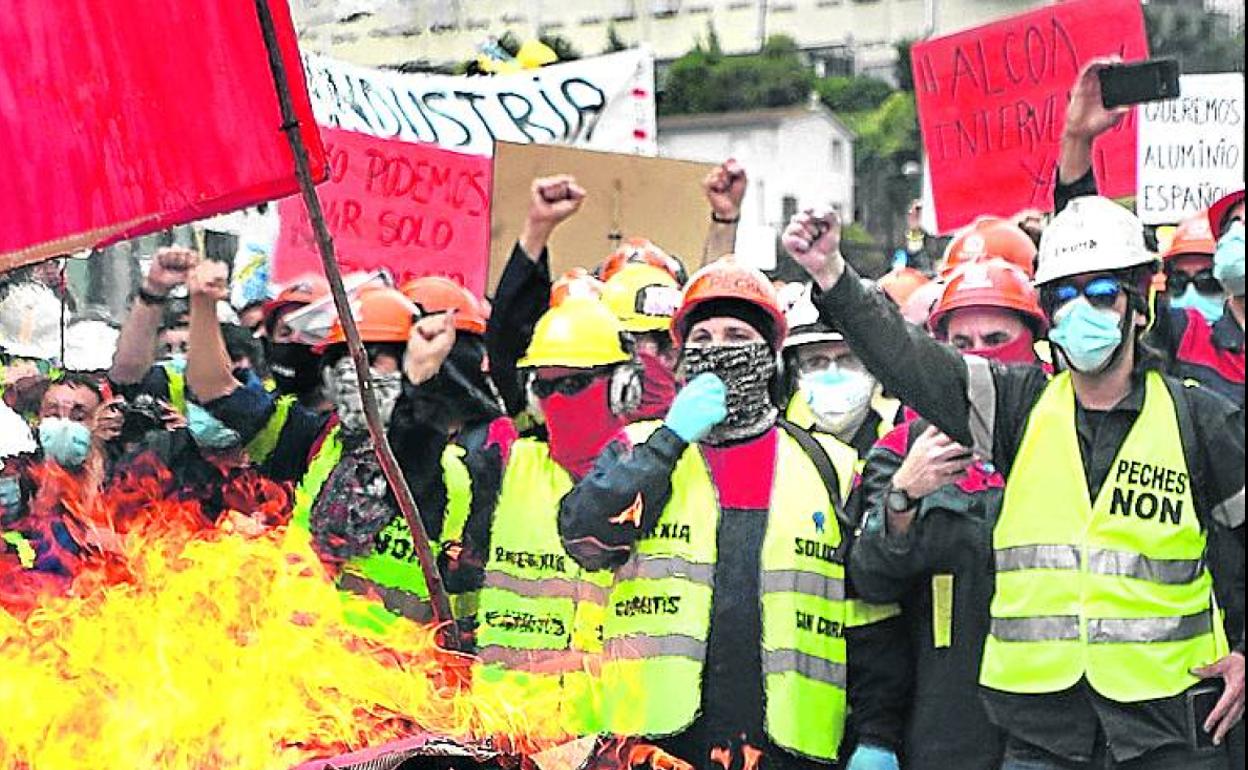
(474, 438, 612, 735)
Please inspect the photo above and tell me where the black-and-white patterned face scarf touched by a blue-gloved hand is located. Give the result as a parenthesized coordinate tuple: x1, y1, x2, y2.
(681, 342, 780, 446)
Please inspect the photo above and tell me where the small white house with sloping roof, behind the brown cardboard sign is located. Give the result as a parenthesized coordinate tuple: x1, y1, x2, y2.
(659, 104, 854, 268)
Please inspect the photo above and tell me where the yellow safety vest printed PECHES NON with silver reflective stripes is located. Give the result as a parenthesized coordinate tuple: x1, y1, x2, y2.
(980, 373, 1227, 703)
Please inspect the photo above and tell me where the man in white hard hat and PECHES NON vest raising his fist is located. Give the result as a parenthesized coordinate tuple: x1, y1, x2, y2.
(784, 197, 1244, 770)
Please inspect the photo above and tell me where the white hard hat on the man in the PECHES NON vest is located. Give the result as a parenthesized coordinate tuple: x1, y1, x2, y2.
(1035, 196, 1157, 286)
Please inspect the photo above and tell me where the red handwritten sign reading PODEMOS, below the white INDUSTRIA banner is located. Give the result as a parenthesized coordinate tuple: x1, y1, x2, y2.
(271, 126, 492, 296)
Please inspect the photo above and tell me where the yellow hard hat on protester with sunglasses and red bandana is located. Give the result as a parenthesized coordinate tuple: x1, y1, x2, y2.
(517, 297, 631, 369)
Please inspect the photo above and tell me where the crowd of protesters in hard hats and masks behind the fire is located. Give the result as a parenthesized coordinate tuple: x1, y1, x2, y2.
(0, 58, 1244, 770)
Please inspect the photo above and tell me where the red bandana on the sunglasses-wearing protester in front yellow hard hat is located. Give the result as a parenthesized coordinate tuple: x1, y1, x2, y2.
(542, 377, 624, 478)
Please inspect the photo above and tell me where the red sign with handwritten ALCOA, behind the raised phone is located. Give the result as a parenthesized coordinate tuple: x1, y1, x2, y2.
(911, 0, 1148, 232)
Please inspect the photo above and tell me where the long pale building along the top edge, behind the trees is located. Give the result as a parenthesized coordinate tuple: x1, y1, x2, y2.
(291, 0, 1043, 79)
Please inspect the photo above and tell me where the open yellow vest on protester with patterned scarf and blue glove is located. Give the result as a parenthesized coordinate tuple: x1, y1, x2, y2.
(603, 431, 897, 760)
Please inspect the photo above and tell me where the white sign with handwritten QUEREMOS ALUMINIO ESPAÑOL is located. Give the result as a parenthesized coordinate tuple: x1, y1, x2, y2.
(1136, 72, 1244, 225)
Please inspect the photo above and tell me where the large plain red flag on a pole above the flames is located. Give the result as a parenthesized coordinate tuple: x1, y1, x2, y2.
(0, 0, 324, 271)
